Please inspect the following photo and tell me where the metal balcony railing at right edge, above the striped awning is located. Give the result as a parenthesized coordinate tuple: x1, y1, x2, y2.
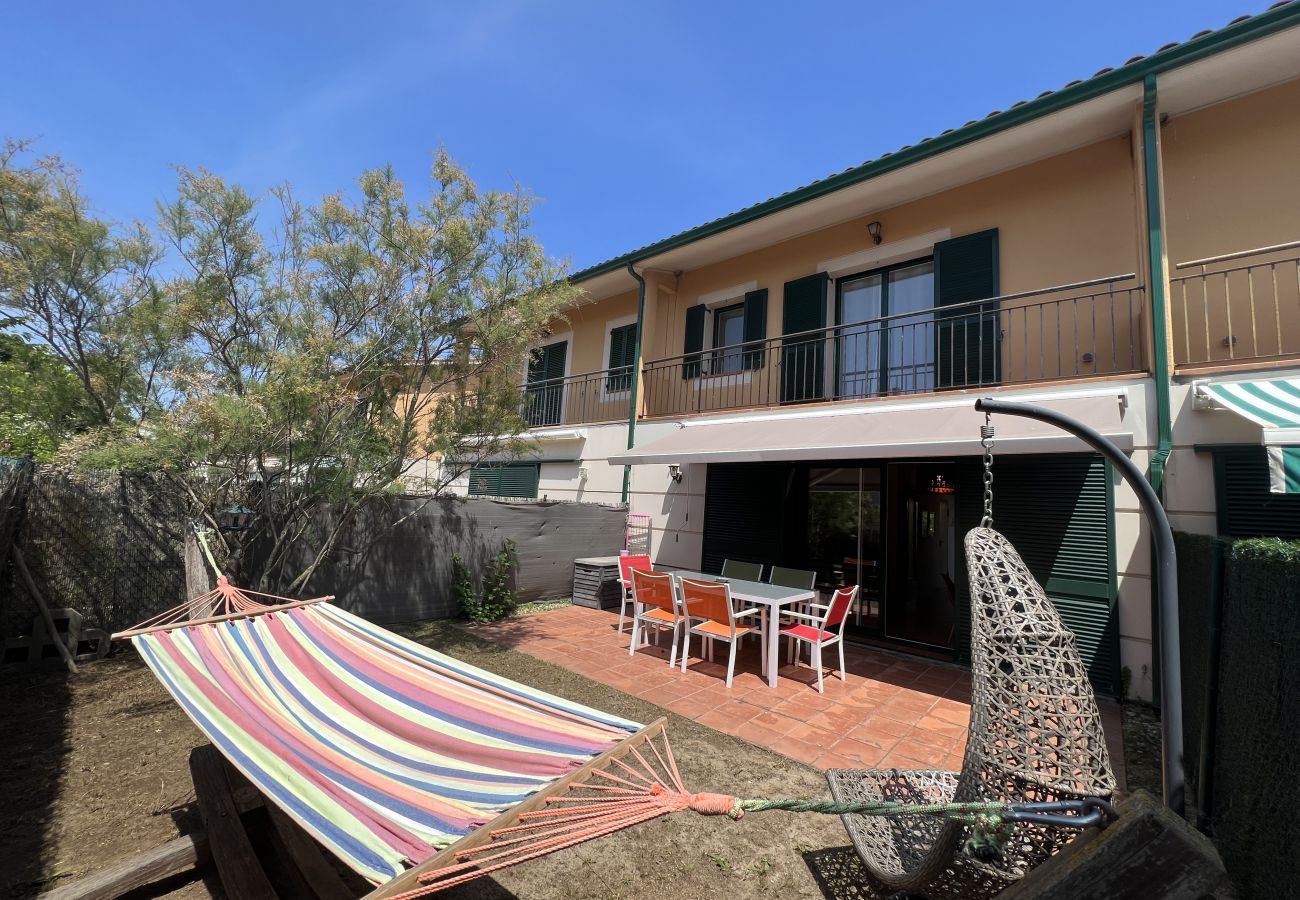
(1170, 241, 1300, 367)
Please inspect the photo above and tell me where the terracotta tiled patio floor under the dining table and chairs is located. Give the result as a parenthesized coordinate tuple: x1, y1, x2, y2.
(467, 606, 1125, 786)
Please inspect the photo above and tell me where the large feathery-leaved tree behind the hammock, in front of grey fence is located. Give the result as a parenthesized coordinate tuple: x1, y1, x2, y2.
(59, 152, 575, 593)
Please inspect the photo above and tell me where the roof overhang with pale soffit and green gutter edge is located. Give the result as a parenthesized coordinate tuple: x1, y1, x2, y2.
(575, 4, 1300, 300)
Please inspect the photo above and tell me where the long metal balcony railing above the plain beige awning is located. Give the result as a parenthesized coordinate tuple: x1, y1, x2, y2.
(644, 274, 1145, 416)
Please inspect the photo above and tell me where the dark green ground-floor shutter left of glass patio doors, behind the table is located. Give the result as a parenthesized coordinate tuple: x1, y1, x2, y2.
(701, 463, 789, 574)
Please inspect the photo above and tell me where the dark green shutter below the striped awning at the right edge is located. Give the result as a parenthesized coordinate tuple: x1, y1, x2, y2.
(1214, 445, 1300, 540)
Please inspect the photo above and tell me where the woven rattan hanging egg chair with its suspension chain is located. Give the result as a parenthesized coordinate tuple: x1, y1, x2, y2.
(827, 410, 1115, 899)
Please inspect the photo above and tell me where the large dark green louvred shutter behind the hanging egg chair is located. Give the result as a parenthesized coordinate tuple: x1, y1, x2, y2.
(957, 454, 1119, 696)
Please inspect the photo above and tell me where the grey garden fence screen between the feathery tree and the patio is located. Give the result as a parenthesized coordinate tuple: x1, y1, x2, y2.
(286, 497, 627, 624)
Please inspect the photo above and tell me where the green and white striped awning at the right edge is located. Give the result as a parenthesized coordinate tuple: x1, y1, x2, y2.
(1197, 378, 1300, 494)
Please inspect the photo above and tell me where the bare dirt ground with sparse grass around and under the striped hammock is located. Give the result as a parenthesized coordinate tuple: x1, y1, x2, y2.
(0, 613, 875, 900)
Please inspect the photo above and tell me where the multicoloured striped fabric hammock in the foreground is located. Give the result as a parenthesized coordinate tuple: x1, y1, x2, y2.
(131, 598, 641, 884)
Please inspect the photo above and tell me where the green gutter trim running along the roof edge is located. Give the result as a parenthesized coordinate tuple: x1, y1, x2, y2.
(569, 0, 1300, 282)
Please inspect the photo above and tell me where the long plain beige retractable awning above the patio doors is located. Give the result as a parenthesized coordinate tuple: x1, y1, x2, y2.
(608, 389, 1134, 466)
